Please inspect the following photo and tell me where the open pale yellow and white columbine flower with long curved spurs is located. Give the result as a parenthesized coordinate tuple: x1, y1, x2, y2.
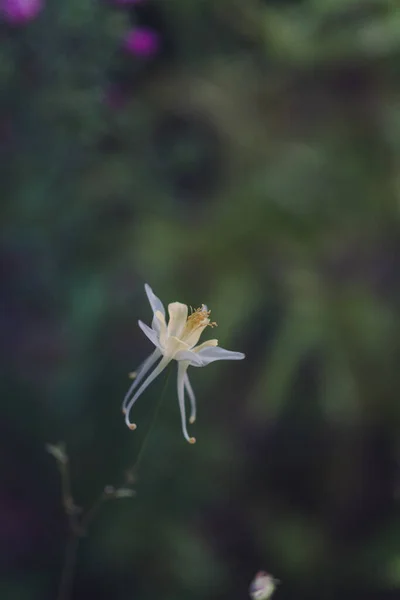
(122, 283, 244, 444)
